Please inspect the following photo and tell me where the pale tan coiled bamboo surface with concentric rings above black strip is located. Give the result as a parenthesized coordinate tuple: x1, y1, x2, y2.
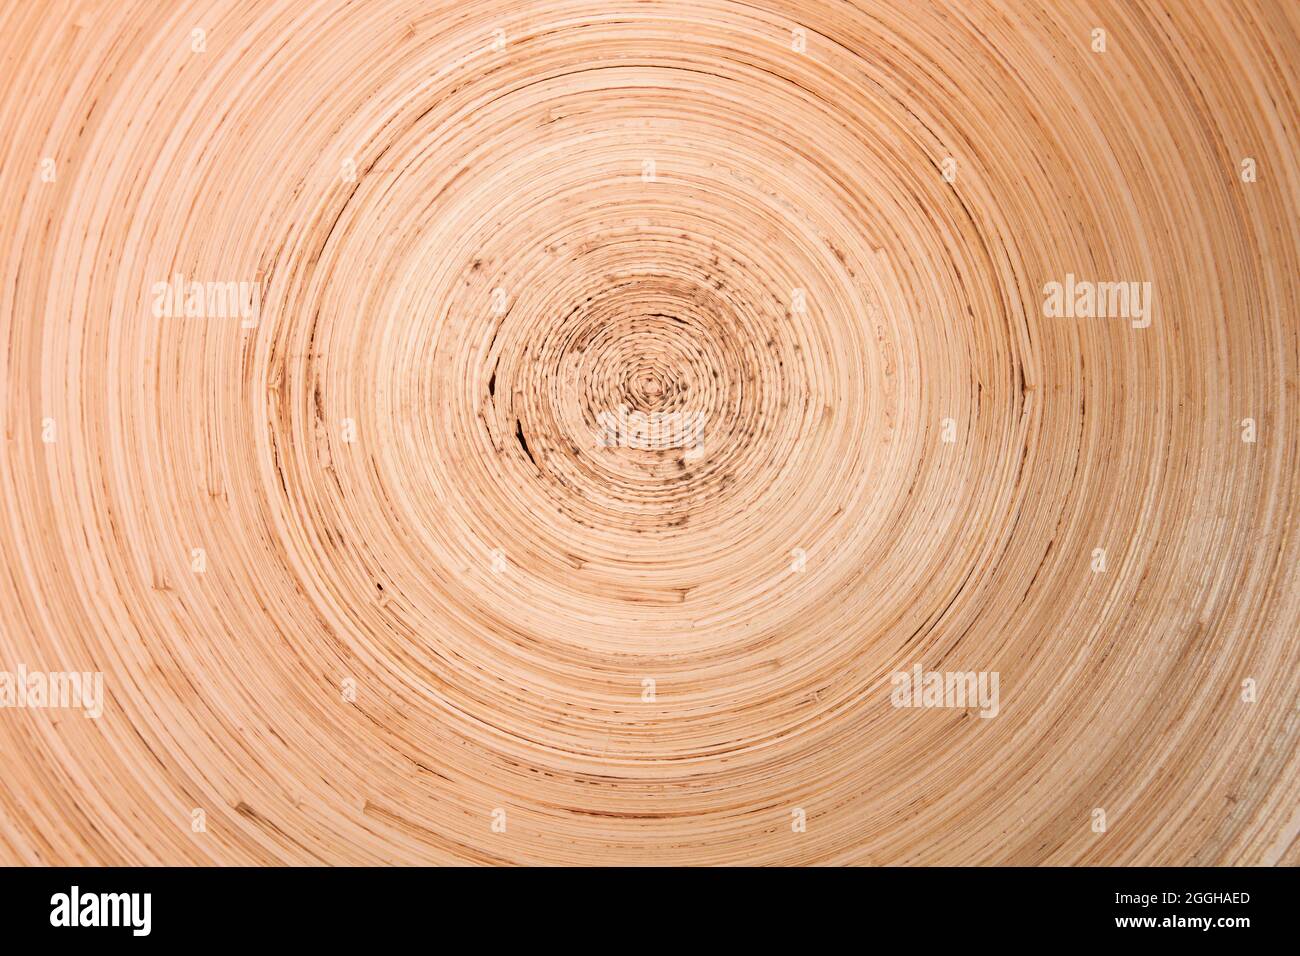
(0, 0, 1300, 865)
